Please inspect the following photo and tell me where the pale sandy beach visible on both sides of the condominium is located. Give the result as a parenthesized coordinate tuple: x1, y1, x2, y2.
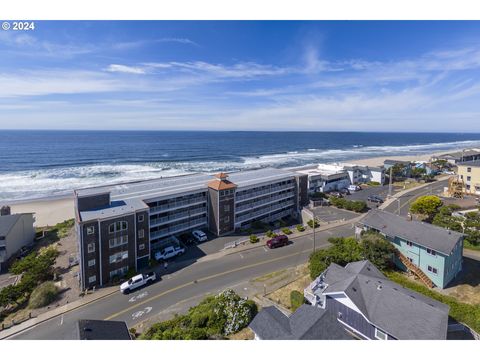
(1, 149, 462, 226)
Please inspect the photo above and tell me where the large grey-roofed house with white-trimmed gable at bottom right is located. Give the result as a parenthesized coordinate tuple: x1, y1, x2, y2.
(304, 260, 450, 340)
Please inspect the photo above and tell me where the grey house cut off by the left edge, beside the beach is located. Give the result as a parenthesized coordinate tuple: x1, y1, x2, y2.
(0, 211, 35, 271)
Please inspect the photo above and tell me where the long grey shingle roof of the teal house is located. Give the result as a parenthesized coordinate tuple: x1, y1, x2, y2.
(359, 210, 463, 255)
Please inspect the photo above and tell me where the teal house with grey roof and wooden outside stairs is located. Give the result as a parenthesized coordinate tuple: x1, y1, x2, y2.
(356, 210, 464, 289)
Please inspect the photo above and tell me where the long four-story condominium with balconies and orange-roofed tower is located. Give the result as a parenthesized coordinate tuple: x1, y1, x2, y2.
(75, 168, 308, 288)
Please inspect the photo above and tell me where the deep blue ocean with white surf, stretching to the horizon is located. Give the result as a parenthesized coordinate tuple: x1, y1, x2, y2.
(0, 130, 480, 202)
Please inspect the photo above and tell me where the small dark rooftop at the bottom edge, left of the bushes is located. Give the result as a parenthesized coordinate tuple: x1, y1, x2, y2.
(77, 320, 132, 340)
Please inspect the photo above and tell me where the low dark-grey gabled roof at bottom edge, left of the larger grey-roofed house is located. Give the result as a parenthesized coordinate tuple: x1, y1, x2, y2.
(249, 304, 353, 340)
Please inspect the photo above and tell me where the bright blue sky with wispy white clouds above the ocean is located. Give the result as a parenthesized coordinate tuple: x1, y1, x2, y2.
(0, 21, 480, 132)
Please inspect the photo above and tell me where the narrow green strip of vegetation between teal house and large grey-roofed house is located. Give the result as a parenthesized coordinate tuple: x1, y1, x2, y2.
(385, 271, 480, 332)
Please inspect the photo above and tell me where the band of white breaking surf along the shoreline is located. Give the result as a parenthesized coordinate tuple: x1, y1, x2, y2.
(0, 141, 480, 203)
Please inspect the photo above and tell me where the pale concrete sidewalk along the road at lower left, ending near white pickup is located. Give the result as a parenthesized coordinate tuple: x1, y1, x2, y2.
(0, 286, 118, 340)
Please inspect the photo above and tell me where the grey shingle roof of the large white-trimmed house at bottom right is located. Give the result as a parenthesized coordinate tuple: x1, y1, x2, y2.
(322, 260, 450, 340)
